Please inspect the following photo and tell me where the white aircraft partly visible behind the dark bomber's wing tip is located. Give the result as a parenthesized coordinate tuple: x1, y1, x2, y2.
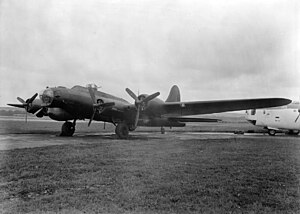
(246, 102, 300, 135)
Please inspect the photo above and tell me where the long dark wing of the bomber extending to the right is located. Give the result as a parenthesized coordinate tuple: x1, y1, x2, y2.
(163, 98, 291, 115)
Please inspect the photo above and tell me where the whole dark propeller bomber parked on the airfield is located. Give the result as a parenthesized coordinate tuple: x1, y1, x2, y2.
(8, 84, 291, 138)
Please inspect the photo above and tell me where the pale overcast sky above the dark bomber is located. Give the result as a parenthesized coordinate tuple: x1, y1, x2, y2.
(0, 0, 300, 106)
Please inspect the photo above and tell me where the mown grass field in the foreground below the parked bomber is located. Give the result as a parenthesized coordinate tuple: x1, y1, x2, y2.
(0, 118, 300, 213)
